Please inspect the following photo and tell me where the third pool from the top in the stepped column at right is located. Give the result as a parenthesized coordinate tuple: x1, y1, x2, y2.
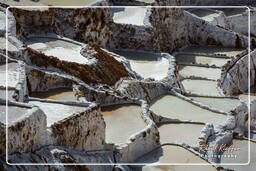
(179, 66, 221, 80)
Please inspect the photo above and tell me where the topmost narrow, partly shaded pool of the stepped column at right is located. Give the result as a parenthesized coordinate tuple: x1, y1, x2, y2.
(183, 46, 244, 57)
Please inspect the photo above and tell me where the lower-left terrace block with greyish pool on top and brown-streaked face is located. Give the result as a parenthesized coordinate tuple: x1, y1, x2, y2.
(0, 100, 46, 155)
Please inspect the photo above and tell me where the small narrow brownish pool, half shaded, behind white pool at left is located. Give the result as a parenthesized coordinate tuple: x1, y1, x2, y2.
(30, 88, 76, 101)
